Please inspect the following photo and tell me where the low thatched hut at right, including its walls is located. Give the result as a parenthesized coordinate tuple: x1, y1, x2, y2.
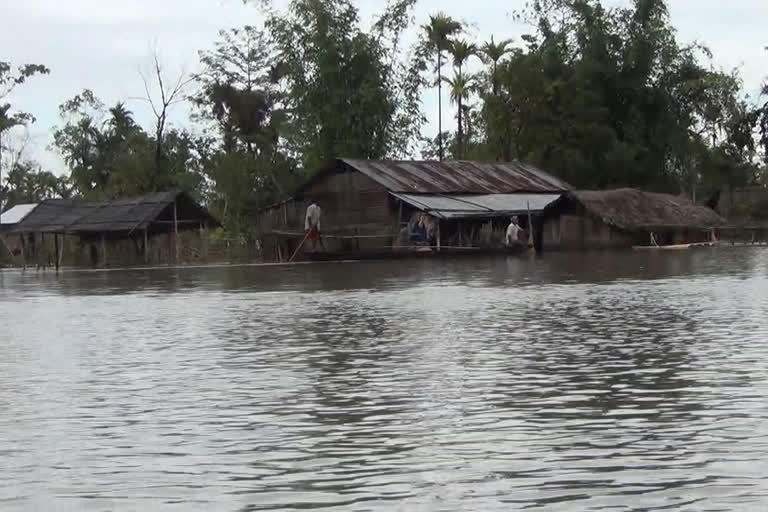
(542, 188, 725, 250)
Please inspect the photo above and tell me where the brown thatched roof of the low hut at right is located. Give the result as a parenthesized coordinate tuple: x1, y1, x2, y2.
(547, 188, 725, 231)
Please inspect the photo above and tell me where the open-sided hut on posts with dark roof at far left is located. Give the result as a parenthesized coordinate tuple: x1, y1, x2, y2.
(10, 191, 220, 266)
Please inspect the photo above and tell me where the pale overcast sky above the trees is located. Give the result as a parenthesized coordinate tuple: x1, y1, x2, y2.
(0, 0, 768, 171)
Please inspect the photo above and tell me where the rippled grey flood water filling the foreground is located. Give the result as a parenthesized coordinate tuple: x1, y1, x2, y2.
(0, 248, 768, 511)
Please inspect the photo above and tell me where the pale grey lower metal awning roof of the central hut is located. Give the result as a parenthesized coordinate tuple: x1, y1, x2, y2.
(392, 193, 560, 219)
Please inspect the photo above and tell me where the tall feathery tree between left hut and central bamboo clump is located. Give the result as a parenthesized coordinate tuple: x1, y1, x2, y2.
(192, 26, 298, 233)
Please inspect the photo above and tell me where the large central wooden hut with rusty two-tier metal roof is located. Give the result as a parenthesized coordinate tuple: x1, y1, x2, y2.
(259, 158, 571, 260)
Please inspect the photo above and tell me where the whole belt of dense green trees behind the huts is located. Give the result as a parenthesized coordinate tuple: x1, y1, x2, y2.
(0, 0, 768, 234)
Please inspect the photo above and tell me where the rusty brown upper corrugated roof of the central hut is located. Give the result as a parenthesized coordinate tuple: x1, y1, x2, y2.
(340, 158, 571, 194)
